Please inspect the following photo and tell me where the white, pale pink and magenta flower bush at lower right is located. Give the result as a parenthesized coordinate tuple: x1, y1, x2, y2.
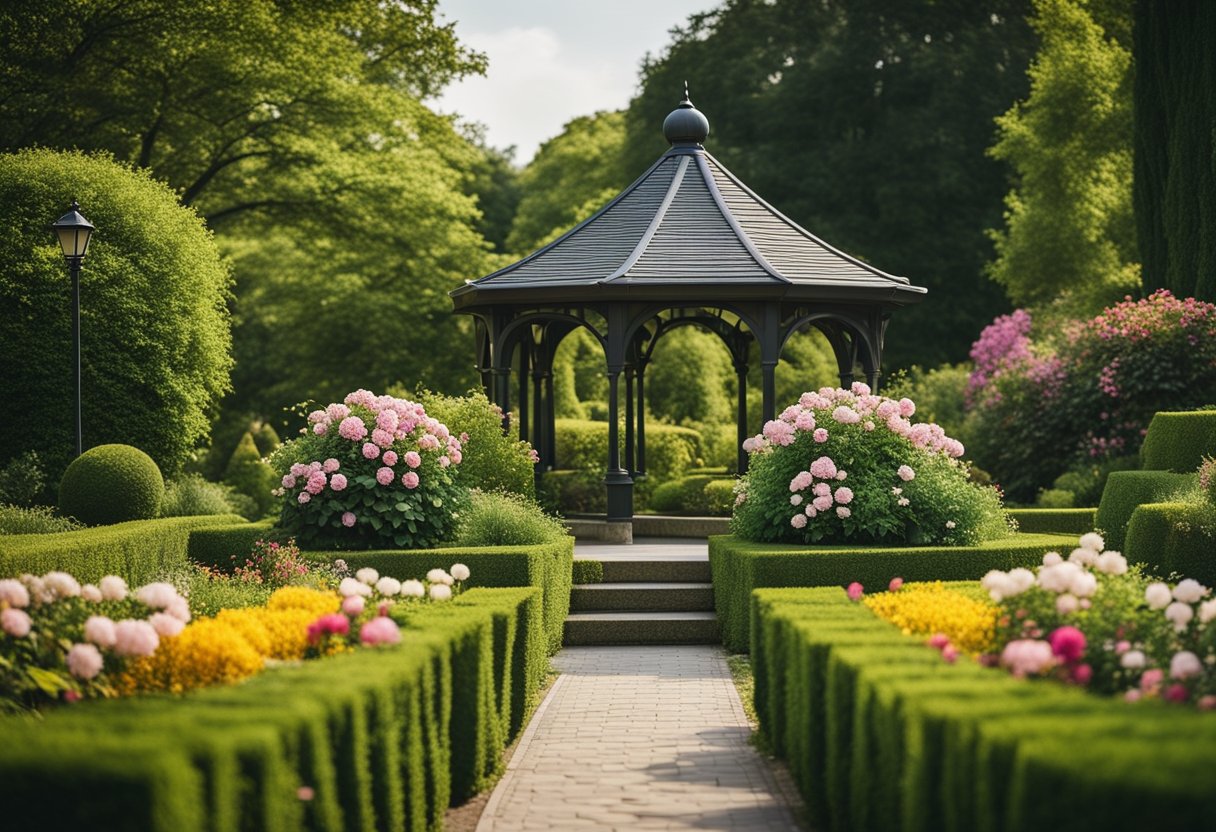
(980, 533, 1216, 709)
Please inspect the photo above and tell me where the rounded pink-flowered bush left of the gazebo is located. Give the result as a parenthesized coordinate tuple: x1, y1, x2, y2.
(271, 390, 468, 549)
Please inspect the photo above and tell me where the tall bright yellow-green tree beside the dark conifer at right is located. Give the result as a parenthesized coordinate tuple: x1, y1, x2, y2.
(990, 0, 1139, 316)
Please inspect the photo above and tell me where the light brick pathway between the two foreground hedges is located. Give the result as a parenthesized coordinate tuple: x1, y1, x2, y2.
(477, 646, 799, 832)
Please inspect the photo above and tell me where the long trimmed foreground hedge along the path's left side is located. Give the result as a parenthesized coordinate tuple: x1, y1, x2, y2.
(0, 589, 545, 832)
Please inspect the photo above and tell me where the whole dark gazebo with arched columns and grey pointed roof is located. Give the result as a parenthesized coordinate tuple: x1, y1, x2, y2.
(451, 90, 925, 538)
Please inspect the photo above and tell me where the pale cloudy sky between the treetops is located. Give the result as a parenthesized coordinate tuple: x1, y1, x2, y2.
(437, 0, 717, 164)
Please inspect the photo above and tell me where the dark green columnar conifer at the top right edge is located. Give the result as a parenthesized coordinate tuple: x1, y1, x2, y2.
(1133, 0, 1216, 300)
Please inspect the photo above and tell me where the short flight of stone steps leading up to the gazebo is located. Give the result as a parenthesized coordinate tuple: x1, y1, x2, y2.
(565, 555, 721, 647)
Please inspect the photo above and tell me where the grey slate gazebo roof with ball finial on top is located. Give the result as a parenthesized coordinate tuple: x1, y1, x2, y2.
(451, 91, 925, 309)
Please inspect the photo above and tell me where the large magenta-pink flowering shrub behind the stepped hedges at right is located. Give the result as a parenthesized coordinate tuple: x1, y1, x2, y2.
(968, 289, 1216, 501)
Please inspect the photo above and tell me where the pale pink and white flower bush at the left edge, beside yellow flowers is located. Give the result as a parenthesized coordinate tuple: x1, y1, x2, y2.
(0, 572, 191, 710)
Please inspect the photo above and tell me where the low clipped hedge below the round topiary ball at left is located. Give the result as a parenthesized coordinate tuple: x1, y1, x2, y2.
(0, 515, 246, 585)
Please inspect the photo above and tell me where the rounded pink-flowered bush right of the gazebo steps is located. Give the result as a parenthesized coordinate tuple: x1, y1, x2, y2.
(732, 383, 1007, 545)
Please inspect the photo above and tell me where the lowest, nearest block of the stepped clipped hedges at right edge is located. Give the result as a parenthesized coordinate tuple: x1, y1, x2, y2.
(1124, 502, 1216, 586)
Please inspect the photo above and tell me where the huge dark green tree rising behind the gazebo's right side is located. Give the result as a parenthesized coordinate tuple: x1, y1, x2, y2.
(626, 0, 1035, 367)
